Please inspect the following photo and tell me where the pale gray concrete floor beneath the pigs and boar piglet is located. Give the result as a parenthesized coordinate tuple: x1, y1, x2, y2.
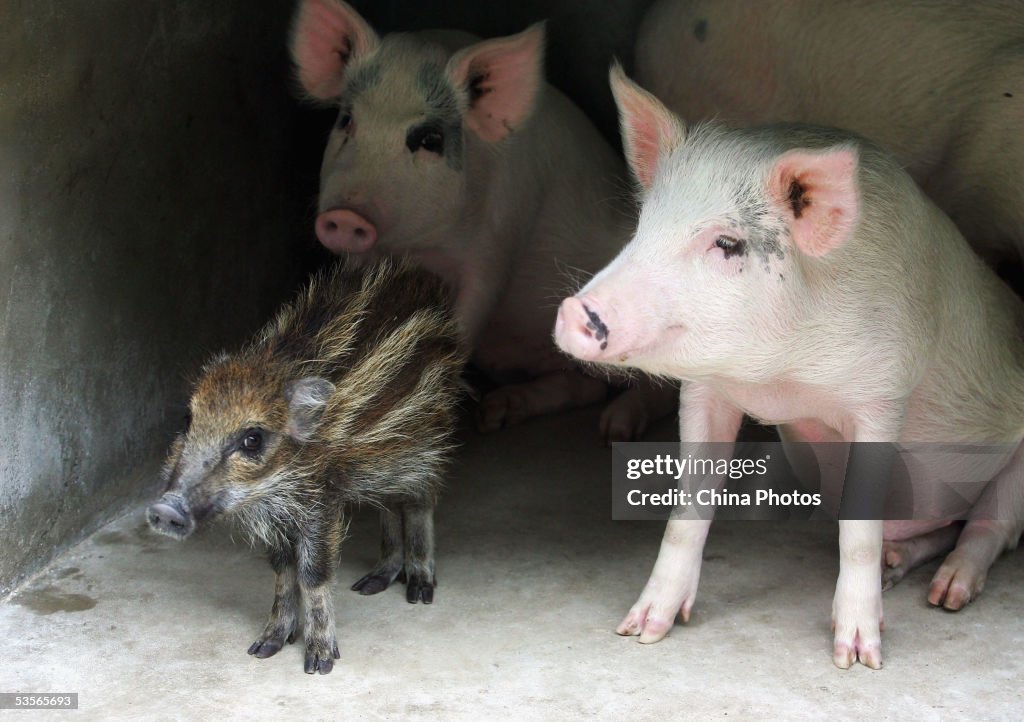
(0, 410, 1024, 720)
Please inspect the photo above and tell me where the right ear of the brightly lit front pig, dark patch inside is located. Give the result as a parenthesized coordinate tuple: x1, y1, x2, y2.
(768, 147, 860, 256)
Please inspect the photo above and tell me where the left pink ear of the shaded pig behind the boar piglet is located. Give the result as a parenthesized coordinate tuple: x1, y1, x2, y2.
(291, 0, 380, 100)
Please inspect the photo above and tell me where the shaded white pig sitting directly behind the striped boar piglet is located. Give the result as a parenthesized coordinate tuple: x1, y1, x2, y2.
(292, 0, 674, 439)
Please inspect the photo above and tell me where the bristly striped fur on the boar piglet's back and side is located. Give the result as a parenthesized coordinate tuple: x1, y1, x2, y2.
(243, 253, 465, 495)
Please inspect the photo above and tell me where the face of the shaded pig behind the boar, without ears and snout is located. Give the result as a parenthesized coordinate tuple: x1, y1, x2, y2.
(317, 33, 471, 250)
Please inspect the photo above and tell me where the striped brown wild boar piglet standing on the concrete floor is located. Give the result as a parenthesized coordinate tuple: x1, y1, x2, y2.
(147, 261, 465, 674)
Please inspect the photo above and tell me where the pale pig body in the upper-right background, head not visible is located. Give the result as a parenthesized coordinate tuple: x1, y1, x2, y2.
(636, 0, 1024, 262)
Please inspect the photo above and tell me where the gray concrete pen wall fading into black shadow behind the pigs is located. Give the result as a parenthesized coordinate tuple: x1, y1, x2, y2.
(0, 0, 647, 595)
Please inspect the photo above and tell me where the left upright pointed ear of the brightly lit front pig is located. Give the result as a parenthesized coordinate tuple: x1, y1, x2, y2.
(608, 62, 686, 189)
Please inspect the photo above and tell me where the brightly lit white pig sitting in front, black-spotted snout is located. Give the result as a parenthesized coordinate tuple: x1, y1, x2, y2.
(555, 70, 1024, 668)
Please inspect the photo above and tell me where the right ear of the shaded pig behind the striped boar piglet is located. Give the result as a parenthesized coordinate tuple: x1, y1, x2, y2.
(447, 23, 545, 142)
